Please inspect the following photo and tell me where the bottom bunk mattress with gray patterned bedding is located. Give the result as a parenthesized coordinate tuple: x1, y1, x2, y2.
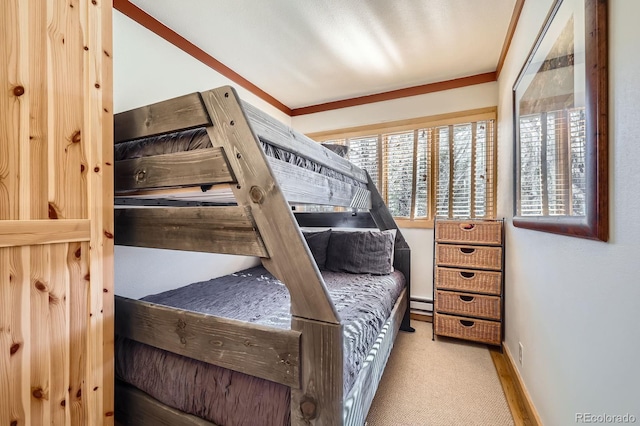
(116, 266, 405, 426)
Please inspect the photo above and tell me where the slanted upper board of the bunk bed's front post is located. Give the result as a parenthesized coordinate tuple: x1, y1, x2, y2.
(202, 87, 339, 324)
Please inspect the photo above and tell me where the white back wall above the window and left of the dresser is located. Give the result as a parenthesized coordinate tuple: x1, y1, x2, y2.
(292, 83, 498, 299)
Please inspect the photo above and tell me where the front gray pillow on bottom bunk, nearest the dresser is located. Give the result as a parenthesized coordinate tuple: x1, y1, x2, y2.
(326, 230, 395, 275)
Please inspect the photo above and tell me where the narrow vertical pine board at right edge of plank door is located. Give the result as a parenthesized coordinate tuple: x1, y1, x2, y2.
(92, 2, 114, 426)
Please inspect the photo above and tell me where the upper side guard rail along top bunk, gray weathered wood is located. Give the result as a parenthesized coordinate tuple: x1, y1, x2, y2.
(241, 102, 367, 183)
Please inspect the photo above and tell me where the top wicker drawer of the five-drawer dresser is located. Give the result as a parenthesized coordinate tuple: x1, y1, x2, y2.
(435, 220, 502, 245)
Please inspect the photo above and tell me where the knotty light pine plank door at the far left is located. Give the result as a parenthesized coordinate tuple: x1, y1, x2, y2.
(0, 0, 113, 426)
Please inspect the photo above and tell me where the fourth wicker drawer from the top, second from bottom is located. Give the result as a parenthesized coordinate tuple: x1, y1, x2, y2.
(436, 290, 500, 320)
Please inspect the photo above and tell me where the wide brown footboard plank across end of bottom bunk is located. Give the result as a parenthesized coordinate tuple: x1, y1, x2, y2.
(115, 296, 300, 388)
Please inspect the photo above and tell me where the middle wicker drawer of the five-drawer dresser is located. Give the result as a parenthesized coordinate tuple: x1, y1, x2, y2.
(436, 267, 502, 294)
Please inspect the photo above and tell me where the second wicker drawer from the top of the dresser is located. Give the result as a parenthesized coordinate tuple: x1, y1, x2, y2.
(436, 243, 502, 271)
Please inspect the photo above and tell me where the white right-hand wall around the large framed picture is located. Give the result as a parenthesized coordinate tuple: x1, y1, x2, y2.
(498, 0, 640, 425)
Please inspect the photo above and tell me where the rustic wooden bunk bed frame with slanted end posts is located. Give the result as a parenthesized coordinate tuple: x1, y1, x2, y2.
(115, 87, 413, 425)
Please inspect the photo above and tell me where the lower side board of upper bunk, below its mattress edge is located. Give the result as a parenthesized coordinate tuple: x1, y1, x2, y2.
(268, 157, 371, 209)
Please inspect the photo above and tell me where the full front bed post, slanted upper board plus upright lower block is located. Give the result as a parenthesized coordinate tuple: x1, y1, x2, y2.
(201, 86, 343, 425)
